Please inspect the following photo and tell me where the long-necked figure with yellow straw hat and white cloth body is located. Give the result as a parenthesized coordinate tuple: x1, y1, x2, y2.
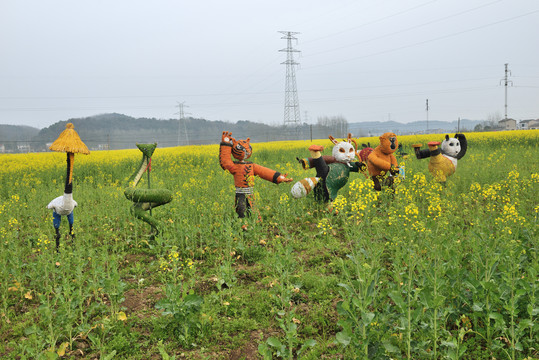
(47, 123, 90, 250)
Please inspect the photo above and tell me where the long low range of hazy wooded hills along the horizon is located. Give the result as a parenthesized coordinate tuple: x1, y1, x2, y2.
(0, 113, 488, 152)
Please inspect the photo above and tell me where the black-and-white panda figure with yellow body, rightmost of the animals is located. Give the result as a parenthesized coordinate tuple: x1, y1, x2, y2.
(412, 134, 468, 183)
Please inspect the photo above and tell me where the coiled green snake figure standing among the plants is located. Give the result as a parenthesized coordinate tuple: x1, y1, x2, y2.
(124, 143, 172, 234)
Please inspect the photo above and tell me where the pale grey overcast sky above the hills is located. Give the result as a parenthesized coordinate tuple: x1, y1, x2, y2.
(0, 0, 539, 128)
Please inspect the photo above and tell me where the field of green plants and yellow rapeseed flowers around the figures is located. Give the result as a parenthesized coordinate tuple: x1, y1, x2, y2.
(0, 130, 539, 360)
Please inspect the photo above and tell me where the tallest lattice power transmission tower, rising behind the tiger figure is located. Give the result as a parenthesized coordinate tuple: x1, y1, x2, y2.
(279, 31, 301, 130)
